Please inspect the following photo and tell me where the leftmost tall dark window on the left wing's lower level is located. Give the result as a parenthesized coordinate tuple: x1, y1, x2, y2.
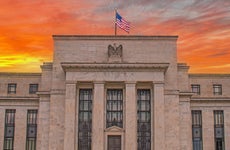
(3, 109, 16, 150)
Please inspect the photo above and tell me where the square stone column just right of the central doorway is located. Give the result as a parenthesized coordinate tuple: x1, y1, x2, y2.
(124, 82, 137, 150)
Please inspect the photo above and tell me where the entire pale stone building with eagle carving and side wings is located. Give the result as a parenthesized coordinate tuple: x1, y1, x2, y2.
(0, 35, 230, 150)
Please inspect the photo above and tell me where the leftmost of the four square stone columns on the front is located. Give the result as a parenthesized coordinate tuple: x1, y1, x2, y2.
(64, 83, 76, 150)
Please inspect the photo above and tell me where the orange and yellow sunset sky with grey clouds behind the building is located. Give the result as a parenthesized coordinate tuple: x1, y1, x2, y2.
(0, 0, 230, 73)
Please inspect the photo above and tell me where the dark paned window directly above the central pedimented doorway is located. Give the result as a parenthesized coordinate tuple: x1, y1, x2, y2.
(106, 89, 123, 128)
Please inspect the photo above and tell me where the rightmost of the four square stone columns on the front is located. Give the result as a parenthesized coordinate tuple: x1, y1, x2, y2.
(152, 83, 165, 150)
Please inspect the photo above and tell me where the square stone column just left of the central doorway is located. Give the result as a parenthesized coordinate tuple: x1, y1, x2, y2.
(92, 82, 105, 150)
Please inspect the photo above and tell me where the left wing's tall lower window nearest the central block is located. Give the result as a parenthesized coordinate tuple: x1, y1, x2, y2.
(26, 110, 38, 150)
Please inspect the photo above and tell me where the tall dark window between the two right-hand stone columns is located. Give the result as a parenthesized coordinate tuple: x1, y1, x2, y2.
(137, 89, 151, 150)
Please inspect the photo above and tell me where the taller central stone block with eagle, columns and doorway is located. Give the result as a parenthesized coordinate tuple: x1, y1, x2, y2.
(43, 35, 180, 150)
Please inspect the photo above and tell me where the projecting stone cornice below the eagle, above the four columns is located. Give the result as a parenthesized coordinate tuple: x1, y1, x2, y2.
(61, 62, 169, 72)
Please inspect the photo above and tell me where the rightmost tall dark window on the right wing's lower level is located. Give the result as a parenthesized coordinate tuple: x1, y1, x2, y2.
(214, 110, 224, 150)
